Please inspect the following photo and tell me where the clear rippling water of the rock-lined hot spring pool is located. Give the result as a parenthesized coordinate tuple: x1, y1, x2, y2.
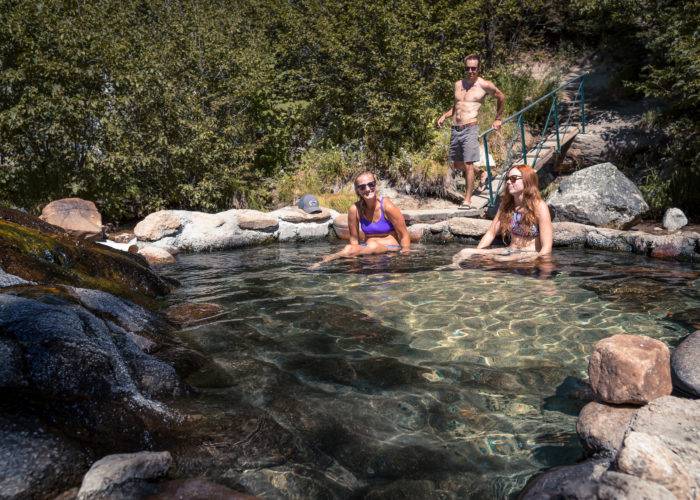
(160, 243, 700, 498)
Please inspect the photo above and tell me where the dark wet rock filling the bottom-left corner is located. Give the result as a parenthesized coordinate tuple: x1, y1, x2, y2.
(0, 415, 89, 498)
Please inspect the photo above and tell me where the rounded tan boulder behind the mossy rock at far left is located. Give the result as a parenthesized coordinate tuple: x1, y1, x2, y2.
(40, 198, 102, 238)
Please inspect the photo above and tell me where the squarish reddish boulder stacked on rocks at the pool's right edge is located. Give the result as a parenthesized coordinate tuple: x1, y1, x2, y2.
(588, 335, 673, 404)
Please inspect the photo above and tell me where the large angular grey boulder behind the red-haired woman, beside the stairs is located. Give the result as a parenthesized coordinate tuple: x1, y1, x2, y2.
(547, 163, 649, 229)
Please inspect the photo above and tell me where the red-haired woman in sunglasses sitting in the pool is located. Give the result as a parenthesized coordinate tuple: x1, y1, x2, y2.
(452, 165, 552, 265)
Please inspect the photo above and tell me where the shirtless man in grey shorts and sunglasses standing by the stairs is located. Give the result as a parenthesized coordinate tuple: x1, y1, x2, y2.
(436, 54, 506, 209)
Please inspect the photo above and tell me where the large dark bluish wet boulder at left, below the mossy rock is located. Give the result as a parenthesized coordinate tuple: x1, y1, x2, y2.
(0, 292, 175, 446)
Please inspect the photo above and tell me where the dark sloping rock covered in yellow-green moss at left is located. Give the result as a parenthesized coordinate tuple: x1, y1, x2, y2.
(0, 209, 170, 304)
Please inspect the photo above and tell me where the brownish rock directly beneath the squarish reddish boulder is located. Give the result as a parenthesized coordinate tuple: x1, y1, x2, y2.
(576, 401, 637, 456)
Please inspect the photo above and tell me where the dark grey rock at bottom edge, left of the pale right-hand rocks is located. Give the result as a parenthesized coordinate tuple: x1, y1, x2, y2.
(519, 458, 610, 500)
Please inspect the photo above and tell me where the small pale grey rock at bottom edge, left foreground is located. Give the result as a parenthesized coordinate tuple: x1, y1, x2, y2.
(78, 451, 173, 500)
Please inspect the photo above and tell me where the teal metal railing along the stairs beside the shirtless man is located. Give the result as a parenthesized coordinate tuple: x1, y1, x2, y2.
(479, 73, 588, 207)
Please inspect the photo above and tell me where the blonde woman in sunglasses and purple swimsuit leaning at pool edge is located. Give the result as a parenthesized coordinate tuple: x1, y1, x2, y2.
(311, 172, 411, 269)
